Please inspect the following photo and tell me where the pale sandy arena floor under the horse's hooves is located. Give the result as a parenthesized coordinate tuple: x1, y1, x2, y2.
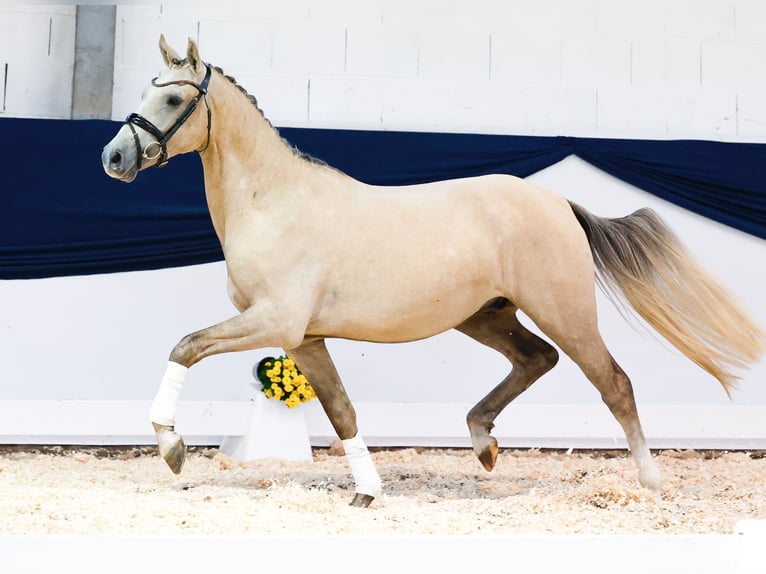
(0, 446, 766, 536)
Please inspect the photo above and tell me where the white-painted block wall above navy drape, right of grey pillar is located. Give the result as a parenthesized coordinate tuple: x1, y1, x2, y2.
(113, 0, 766, 141)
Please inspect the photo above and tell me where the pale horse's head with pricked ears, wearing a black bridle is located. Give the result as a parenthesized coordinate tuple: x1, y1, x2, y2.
(101, 36, 211, 182)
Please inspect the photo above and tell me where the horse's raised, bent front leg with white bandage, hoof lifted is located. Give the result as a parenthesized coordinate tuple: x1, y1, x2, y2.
(150, 307, 303, 474)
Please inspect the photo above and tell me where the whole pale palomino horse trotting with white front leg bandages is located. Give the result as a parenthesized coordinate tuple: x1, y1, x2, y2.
(102, 37, 764, 506)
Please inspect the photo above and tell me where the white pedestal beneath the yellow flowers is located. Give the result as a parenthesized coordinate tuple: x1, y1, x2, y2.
(218, 390, 313, 461)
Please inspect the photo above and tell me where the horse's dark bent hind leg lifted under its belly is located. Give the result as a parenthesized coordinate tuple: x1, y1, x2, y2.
(456, 299, 558, 470)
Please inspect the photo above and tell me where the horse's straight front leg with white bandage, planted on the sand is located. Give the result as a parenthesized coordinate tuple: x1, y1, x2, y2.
(288, 339, 381, 507)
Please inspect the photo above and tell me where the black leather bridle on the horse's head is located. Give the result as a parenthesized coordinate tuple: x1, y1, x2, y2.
(125, 64, 212, 170)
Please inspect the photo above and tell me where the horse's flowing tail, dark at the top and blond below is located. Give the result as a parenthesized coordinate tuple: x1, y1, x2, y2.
(569, 202, 766, 396)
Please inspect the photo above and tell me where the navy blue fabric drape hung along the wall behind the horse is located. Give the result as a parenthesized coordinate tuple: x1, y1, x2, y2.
(0, 118, 766, 279)
